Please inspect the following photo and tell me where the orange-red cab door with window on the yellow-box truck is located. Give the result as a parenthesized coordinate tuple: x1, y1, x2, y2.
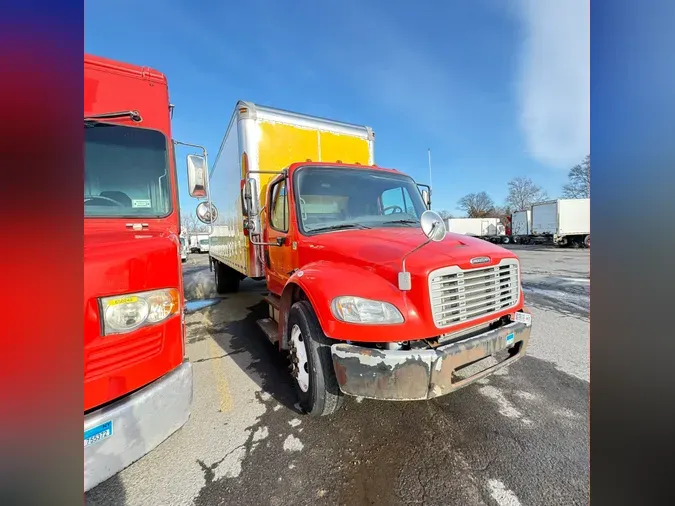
(264, 177, 293, 295)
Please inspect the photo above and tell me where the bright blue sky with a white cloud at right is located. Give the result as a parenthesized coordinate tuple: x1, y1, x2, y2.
(85, 0, 590, 215)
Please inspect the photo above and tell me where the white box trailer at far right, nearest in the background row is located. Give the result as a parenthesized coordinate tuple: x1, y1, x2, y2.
(531, 198, 591, 247)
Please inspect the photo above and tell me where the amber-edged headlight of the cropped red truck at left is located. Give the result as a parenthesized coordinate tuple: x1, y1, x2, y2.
(101, 288, 180, 335)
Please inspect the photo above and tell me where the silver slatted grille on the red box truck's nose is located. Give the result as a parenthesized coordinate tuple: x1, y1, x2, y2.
(429, 258, 520, 328)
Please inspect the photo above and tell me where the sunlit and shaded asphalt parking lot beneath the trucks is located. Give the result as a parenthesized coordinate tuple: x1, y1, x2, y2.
(86, 246, 590, 506)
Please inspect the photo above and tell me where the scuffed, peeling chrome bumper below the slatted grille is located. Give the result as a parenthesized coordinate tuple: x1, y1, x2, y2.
(331, 323, 532, 401)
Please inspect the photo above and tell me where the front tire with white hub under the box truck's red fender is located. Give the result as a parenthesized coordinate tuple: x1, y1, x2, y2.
(288, 300, 344, 417)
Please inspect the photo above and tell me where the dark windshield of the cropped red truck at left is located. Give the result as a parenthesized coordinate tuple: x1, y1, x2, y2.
(84, 121, 171, 218)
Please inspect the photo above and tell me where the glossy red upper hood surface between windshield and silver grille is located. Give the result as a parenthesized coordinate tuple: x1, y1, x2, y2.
(303, 227, 516, 282)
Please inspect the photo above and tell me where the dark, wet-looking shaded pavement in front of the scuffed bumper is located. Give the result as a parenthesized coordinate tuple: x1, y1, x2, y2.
(195, 357, 589, 506)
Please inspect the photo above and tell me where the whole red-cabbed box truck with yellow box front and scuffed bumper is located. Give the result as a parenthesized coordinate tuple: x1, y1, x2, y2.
(188, 102, 531, 415)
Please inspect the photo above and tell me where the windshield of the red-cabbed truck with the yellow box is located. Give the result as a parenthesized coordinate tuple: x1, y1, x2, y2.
(294, 167, 426, 233)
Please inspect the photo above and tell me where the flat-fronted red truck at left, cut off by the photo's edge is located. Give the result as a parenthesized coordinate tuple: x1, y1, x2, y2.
(84, 54, 192, 491)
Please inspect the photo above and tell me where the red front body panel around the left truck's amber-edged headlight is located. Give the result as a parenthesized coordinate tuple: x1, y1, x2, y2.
(83, 227, 184, 411)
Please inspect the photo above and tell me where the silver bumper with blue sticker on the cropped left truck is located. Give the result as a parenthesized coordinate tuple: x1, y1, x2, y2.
(84, 361, 192, 492)
